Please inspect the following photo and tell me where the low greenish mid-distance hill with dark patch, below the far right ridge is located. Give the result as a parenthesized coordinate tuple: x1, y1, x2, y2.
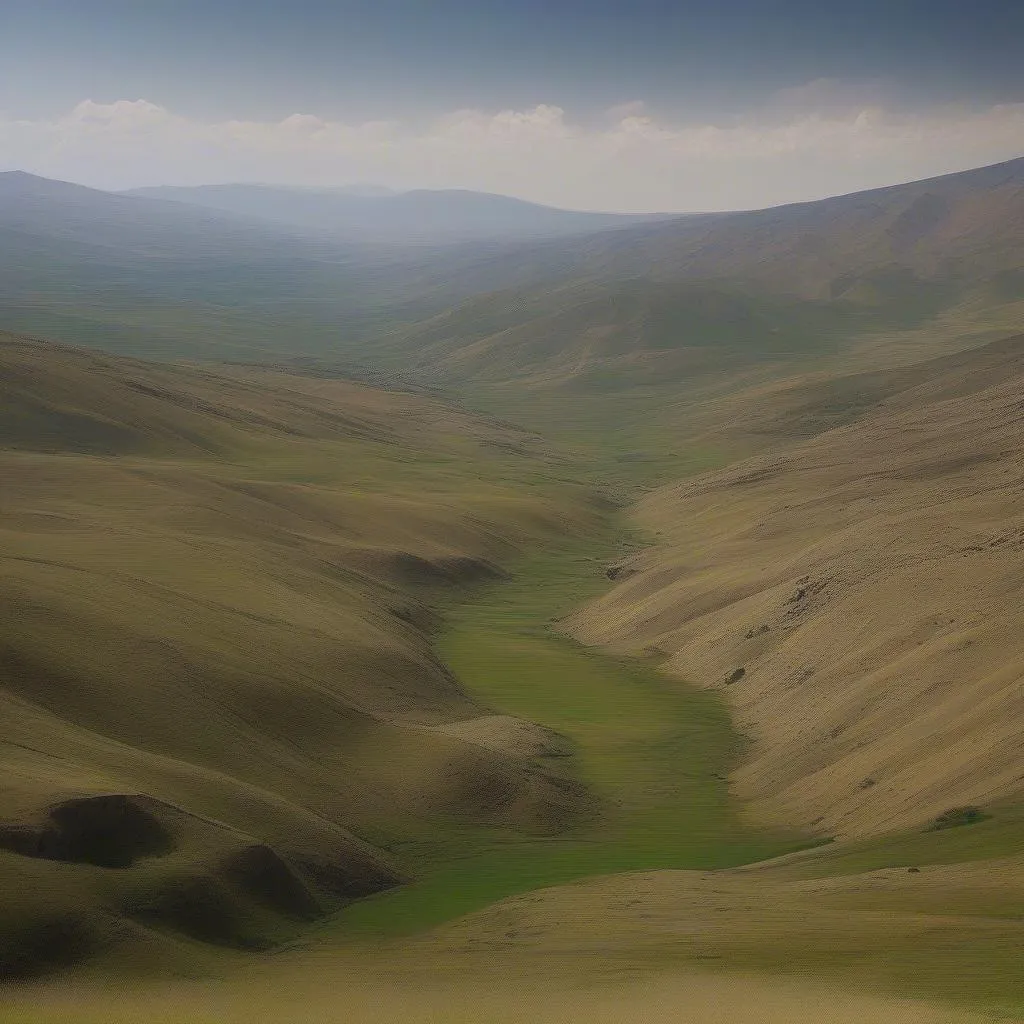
(378, 279, 873, 392)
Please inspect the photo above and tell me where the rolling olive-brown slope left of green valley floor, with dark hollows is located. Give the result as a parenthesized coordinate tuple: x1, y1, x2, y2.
(0, 336, 597, 973)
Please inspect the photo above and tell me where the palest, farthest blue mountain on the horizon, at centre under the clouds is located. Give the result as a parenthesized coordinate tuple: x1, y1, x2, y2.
(129, 184, 651, 244)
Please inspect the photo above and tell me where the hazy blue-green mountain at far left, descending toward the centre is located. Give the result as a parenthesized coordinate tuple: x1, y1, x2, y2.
(0, 172, 569, 358)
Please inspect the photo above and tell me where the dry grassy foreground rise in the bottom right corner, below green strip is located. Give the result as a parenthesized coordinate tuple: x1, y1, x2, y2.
(411, 808, 1024, 1011)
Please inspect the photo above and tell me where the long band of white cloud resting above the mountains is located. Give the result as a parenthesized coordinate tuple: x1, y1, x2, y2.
(0, 92, 1024, 210)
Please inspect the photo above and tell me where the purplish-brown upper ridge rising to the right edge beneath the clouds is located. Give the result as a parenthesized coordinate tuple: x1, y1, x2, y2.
(565, 152, 1024, 300)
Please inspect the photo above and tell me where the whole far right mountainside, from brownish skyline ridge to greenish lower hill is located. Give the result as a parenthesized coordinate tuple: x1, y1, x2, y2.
(375, 160, 1024, 388)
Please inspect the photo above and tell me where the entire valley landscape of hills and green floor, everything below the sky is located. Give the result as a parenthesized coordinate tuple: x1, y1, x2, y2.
(0, 153, 1024, 1024)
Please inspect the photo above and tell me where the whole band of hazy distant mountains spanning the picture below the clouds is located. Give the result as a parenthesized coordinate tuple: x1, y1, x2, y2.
(0, 160, 1024, 388)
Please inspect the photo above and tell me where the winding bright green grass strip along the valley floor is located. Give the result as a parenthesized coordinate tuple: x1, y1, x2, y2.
(332, 539, 805, 938)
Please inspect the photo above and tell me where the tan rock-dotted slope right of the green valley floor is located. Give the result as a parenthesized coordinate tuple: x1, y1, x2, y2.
(570, 337, 1024, 836)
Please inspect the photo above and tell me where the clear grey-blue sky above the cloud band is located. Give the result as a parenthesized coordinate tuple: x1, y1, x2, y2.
(8, 0, 1024, 117)
